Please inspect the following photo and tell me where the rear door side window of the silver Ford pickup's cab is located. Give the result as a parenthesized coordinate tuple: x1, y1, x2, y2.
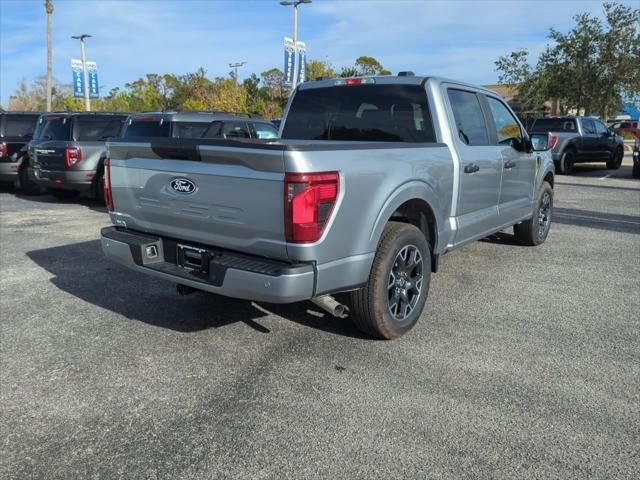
(448, 89, 489, 145)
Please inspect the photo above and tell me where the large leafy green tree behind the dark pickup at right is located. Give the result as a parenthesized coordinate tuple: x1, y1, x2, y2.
(495, 3, 640, 121)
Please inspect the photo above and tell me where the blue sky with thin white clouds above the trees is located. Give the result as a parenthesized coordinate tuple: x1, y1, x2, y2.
(0, 0, 635, 107)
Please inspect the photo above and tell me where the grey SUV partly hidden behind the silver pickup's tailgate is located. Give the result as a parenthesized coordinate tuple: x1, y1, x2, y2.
(122, 111, 278, 138)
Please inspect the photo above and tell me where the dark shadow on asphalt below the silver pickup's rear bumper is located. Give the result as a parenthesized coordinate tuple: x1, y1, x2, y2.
(27, 240, 367, 338)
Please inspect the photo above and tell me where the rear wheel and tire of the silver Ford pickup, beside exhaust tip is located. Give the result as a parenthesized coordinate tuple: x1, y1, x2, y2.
(350, 222, 431, 340)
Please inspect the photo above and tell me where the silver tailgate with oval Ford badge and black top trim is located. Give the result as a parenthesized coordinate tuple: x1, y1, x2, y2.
(108, 140, 287, 259)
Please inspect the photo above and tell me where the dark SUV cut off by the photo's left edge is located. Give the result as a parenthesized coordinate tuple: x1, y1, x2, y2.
(0, 112, 40, 193)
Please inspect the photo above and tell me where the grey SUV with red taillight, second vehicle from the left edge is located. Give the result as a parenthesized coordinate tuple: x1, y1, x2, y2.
(28, 112, 127, 199)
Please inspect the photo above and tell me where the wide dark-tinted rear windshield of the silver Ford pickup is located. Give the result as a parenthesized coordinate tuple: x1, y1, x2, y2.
(282, 85, 435, 143)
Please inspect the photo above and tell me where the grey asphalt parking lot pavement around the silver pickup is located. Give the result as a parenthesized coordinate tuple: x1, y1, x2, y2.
(0, 158, 640, 480)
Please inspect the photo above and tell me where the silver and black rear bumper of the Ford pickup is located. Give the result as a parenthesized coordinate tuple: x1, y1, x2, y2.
(101, 227, 315, 303)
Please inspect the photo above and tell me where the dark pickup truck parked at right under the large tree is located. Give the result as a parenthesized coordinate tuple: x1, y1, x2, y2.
(529, 116, 624, 174)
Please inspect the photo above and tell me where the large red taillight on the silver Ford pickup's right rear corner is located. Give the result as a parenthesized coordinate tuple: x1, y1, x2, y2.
(284, 172, 340, 243)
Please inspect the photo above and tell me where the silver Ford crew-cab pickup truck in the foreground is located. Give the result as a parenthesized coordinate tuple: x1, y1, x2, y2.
(102, 74, 554, 339)
